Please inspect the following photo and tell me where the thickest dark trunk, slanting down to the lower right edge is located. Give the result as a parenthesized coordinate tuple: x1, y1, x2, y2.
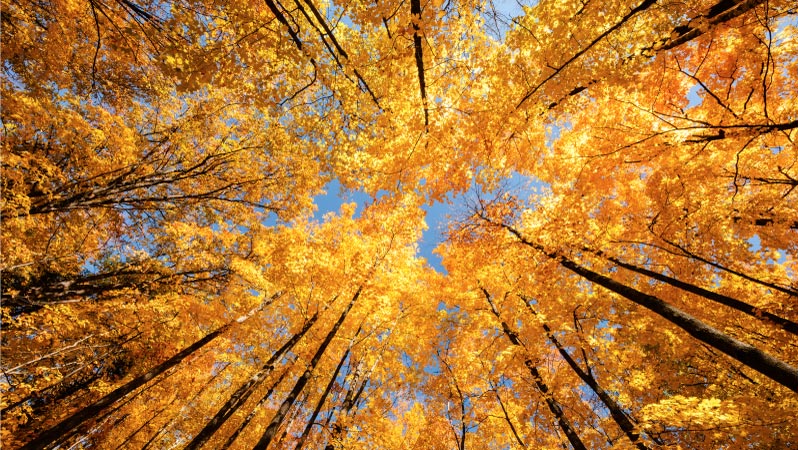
(494, 220, 798, 392)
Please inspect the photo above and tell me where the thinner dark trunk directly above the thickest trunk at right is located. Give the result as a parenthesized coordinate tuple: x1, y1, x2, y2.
(586, 249, 798, 335)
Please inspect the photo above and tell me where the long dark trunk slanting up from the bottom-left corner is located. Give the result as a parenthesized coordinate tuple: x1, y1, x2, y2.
(21, 292, 282, 450)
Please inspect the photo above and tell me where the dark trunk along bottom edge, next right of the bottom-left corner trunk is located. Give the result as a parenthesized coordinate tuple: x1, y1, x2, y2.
(185, 312, 319, 450)
